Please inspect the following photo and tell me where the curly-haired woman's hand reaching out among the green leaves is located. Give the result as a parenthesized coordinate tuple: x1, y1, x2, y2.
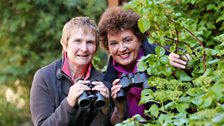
(169, 52, 191, 69)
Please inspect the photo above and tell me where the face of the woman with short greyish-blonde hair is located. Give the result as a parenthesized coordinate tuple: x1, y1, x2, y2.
(65, 28, 96, 66)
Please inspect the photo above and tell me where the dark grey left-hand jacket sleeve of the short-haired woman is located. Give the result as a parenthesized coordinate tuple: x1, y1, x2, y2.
(30, 70, 77, 126)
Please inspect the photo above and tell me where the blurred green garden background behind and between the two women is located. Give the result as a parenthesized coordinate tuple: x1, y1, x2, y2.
(0, 0, 128, 126)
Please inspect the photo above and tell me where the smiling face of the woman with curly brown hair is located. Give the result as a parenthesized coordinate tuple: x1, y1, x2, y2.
(107, 30, 141, 69)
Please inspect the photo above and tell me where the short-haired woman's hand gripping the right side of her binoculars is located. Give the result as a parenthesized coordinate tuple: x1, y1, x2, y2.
(92, 81, 110, 115)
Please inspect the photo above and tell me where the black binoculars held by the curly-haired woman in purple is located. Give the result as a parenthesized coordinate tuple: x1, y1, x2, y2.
(116, 72, 149, 102)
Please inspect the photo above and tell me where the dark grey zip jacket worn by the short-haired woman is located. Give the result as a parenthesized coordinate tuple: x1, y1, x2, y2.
(30, 60, 111, 126)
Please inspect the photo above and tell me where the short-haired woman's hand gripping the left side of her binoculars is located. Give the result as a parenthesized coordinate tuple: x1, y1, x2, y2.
(67, 80, 91, 107)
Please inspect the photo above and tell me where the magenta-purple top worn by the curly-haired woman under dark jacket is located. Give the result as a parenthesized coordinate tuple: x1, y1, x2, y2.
(113, 49, 145, 118)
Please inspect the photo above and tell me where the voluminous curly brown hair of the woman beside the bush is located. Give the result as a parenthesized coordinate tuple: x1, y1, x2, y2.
(98, 6, 144, 50)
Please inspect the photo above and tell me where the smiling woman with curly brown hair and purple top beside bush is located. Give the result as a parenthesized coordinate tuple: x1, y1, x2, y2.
(98, 7, 186, 124)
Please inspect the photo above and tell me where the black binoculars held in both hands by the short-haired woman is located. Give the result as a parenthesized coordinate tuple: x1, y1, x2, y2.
(78, 80, 105, 109)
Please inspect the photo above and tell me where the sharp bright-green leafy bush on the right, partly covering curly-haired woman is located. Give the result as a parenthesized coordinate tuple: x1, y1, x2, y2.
(121, 0, 224, 126)
